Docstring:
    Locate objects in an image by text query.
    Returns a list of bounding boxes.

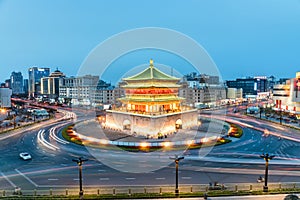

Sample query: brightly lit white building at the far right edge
[272,72,300,115]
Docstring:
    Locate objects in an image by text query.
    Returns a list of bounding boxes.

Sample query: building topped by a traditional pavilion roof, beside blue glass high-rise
[41,69,66,99]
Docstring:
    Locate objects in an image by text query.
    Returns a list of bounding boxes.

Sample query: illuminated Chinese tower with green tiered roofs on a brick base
[102,60,198,138]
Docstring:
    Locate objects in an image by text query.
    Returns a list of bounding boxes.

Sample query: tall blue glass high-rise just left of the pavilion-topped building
[28,67,50,97]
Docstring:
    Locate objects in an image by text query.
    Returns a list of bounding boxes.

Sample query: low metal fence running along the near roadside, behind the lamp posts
[0,182,300,197]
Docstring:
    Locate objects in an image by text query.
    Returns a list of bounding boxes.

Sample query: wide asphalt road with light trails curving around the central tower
[0,108,300,193]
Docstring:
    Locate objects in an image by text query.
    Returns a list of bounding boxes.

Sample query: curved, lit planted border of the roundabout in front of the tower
[62,124,231,152]
